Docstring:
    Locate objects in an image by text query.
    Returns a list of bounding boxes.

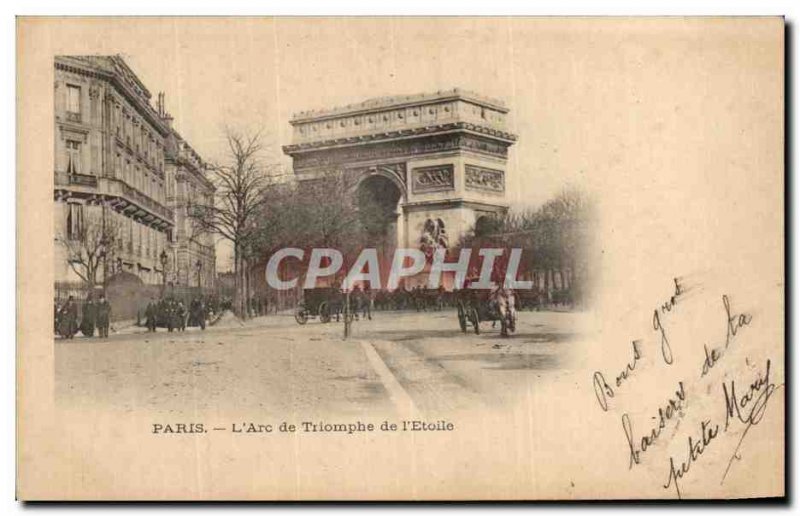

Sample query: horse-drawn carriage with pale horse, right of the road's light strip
[456,289,517,337]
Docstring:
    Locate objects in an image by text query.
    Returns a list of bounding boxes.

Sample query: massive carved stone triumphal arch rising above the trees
[283,89,516,258]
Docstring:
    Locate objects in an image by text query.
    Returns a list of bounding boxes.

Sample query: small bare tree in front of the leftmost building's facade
[56,212,120,289]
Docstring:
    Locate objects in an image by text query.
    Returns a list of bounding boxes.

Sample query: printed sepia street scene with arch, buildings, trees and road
[54,55,591,422]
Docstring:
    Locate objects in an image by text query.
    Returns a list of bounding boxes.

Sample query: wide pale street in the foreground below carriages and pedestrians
[55,310,584,418]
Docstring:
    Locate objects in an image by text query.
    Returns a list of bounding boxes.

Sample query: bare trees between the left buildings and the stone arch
[190,131,380,318]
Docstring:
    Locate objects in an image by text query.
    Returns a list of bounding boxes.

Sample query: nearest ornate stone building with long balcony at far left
[54,56,213,286]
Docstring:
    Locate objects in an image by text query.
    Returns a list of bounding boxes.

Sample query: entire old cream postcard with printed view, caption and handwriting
[17,17,787,500]
